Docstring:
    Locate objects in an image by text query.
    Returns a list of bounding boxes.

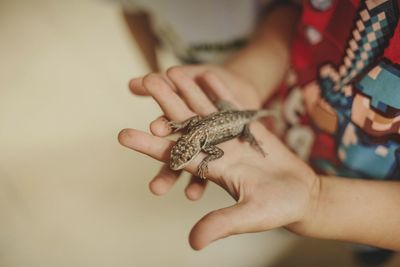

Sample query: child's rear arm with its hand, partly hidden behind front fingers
[130,2,300,108]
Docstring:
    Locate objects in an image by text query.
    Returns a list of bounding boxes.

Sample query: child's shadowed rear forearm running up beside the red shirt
[224,4,300,101]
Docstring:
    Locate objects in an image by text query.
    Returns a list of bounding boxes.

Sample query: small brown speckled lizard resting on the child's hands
[168,101,274,179]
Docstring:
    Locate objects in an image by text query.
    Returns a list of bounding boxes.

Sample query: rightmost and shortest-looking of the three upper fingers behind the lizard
[201,71,240,107]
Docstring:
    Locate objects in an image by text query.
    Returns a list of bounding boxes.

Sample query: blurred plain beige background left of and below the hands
[0,0,396,267]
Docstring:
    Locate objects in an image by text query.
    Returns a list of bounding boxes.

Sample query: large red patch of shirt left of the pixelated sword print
[291,0,359,85]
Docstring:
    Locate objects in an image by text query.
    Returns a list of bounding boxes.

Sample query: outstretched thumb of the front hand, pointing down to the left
[189,202,254,250]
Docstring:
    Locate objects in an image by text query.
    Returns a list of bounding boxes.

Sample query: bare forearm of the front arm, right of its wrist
[294,176,400,250]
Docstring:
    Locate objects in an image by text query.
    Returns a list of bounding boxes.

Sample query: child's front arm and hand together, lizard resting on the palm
[119,72,400,249]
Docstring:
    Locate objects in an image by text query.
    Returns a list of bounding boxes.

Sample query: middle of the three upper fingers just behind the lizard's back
[167,67,216,116]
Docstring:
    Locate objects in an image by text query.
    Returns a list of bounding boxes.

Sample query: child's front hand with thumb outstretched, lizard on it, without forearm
[119,70,319,249]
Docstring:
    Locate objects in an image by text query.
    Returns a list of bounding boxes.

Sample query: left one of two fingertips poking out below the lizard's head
[149,164,182,196]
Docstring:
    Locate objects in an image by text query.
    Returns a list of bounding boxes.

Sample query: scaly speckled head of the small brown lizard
[170,138,201,170]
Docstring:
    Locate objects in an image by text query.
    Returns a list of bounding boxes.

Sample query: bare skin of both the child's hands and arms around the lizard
[119,3,400,250]
